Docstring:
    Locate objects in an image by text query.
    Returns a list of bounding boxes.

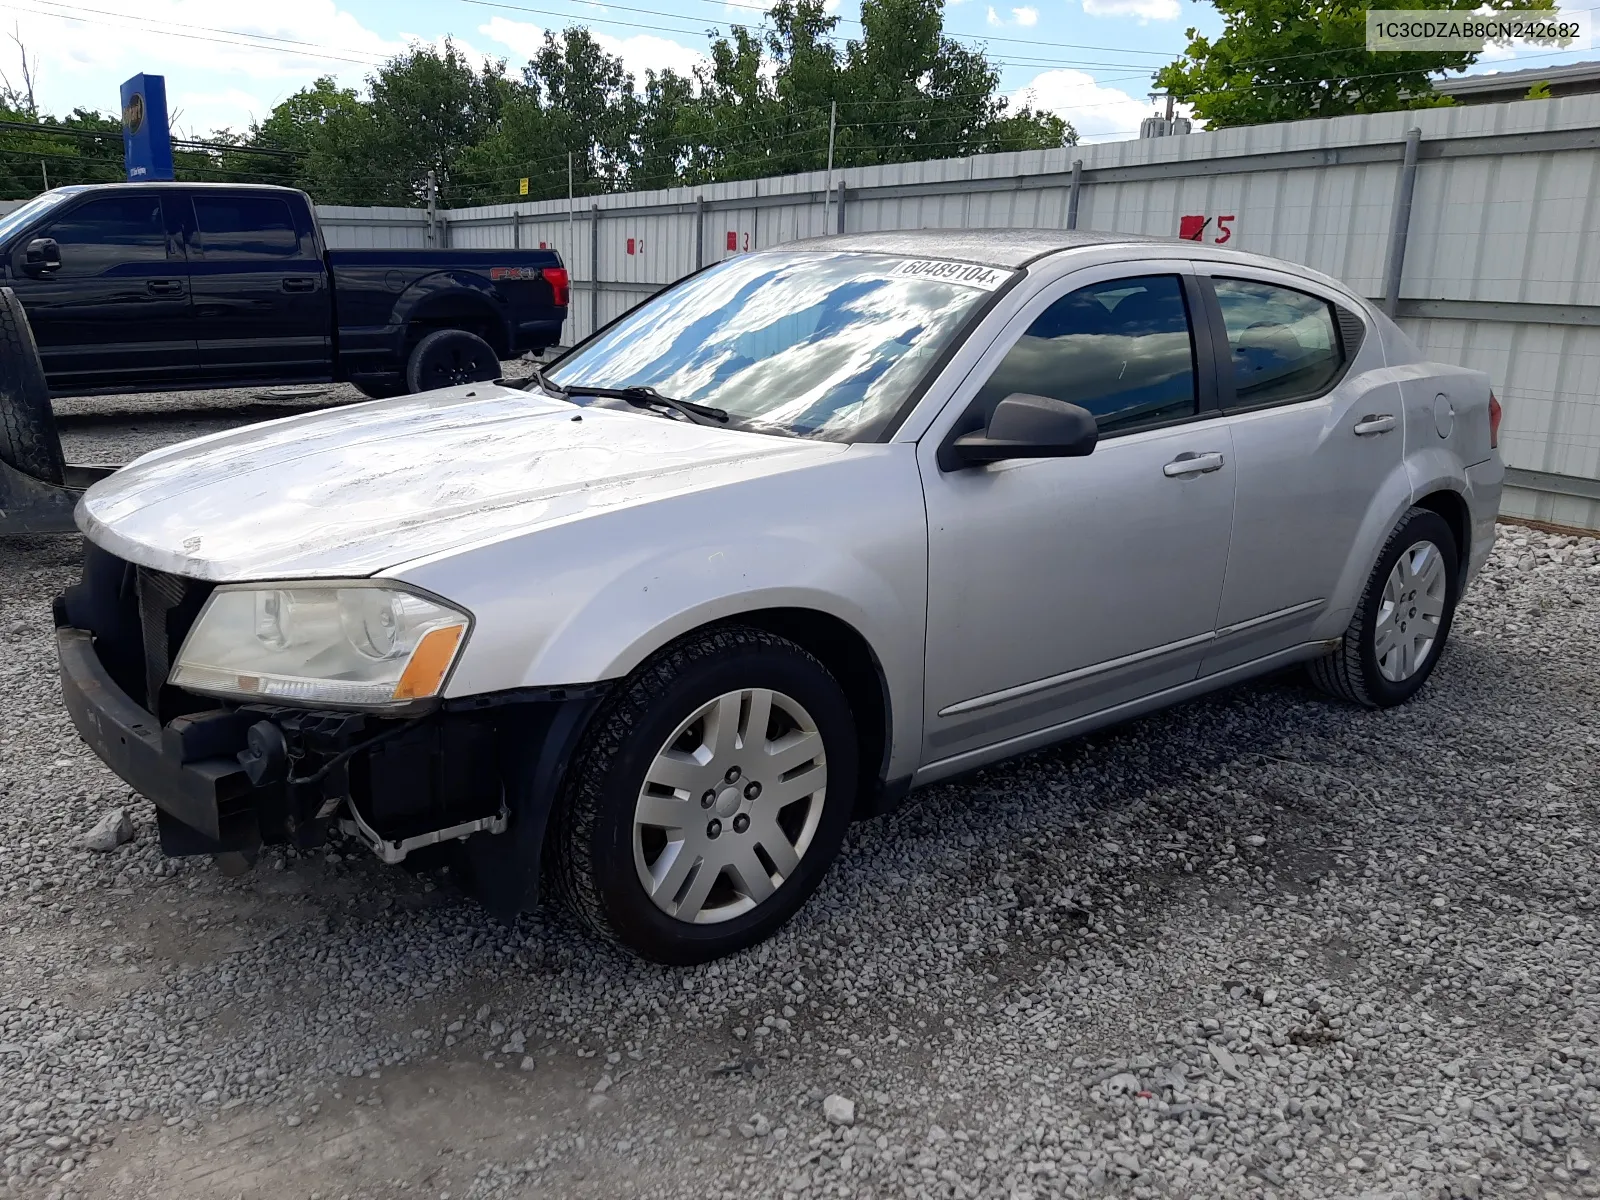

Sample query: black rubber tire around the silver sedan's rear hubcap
[1307,509,1461,709]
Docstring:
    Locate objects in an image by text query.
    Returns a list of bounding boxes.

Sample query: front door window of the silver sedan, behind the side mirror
[979,275,1198,434]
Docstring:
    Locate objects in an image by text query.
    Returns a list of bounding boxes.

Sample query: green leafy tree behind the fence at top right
[1155,0,1552,128]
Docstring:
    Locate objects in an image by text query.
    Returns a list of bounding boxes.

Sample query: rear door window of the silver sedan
[1211,278,1344,408]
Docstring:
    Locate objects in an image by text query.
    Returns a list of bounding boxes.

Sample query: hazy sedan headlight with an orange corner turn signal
[170,584,470,707]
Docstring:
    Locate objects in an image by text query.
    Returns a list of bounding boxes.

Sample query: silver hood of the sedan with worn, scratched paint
[77,384,846,582]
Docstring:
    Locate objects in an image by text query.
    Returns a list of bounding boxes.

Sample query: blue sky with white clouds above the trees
[0,0,1600,141]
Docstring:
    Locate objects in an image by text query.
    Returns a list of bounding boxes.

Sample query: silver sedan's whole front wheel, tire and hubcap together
[552,626,858,965]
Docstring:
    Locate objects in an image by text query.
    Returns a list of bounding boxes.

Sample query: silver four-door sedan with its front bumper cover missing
[58,230,1504,963]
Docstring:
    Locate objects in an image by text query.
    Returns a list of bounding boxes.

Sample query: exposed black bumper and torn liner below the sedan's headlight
[56,605,605,915]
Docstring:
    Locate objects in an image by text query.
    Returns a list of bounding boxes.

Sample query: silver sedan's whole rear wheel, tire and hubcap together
[1307,509,1459,709]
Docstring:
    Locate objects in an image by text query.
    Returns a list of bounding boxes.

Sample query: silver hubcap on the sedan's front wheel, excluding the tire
[634,688,827,925]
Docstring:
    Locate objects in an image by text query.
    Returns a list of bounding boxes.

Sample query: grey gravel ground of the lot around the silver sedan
[0,396,1600,1200]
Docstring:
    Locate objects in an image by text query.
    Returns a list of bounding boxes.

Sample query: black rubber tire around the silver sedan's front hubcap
[550,626,858,965]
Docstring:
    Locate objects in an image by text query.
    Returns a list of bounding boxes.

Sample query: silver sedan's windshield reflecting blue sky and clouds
[550,251,1010,442]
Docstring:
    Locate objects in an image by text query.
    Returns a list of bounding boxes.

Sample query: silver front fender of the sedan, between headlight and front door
[388,445,928,778]
